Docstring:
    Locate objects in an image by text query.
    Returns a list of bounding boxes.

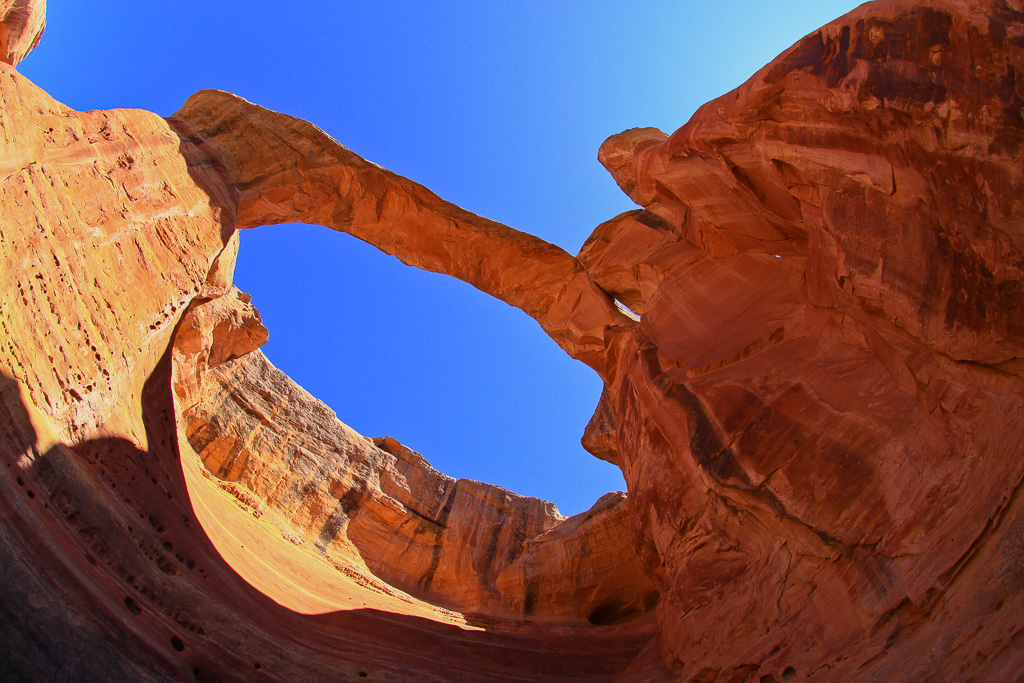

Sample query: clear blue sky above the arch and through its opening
[19,0,859,514]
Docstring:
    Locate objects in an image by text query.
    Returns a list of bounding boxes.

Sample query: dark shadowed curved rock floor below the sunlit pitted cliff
[0,350,663,681]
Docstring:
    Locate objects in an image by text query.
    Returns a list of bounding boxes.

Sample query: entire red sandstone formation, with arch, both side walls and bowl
[0,0,1024,681]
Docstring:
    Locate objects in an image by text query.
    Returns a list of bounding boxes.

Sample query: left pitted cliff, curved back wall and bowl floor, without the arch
[0,57,656,681]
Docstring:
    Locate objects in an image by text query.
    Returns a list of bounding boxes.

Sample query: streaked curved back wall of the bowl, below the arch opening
[173,290,657,630]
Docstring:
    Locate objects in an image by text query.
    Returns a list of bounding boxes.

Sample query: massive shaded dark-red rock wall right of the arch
[593,2,1024,680]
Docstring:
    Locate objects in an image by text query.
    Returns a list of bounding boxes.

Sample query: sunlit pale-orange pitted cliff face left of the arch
[0,58,231,447]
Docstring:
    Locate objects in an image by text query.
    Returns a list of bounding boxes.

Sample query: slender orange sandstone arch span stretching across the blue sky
[170,90,629,373]
